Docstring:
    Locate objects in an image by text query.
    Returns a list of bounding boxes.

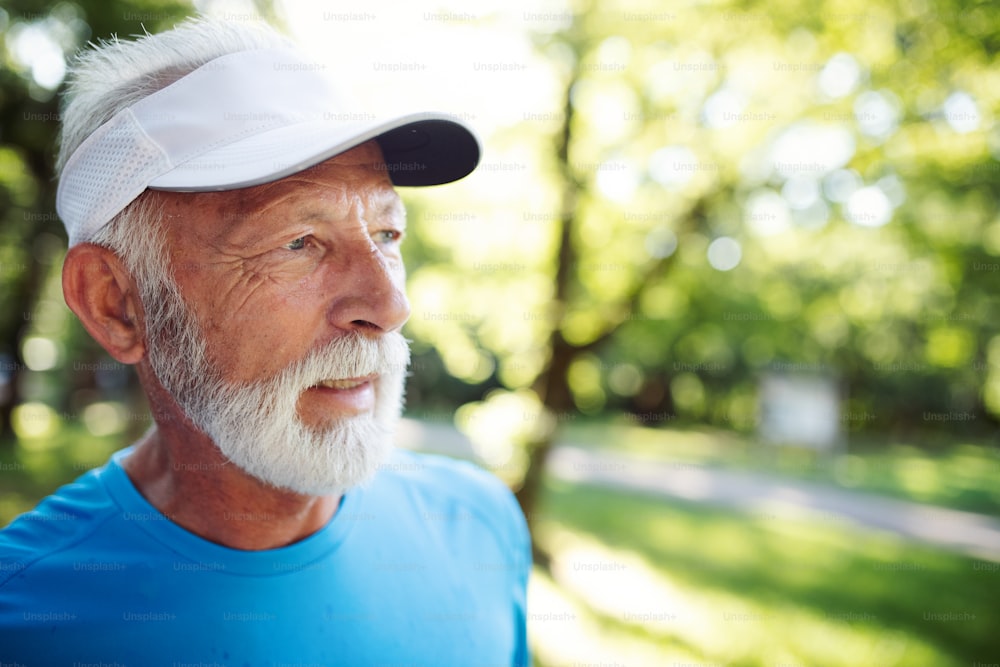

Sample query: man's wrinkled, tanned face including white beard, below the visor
[140,142,409,495]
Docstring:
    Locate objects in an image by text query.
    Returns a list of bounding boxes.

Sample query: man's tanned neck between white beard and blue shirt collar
[123,418,340,551]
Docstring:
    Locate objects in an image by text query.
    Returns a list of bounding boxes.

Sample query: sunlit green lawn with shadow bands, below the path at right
[530,480,1000,667]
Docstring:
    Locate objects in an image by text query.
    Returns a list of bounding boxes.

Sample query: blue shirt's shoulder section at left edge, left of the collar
[0,468,114,588]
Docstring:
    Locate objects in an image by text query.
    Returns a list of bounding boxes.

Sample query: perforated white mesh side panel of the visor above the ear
[56,109,170,245]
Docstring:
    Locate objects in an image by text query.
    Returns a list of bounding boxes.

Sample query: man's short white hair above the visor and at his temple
[56,18,289,294]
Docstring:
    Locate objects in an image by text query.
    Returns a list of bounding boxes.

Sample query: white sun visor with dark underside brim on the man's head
[56,49,481,246]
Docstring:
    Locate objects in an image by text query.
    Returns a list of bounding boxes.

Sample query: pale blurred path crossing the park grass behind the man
[399,419,1000,562]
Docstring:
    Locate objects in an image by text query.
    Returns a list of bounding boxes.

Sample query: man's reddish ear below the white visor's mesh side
[63,243,146,364]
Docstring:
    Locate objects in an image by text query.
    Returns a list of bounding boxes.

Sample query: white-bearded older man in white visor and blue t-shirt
[0,15,530,667]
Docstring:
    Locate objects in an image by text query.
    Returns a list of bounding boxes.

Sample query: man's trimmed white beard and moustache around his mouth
[147,278,410,496]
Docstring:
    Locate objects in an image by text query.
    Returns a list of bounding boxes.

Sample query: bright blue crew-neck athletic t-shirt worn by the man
[0,450,531,667]
